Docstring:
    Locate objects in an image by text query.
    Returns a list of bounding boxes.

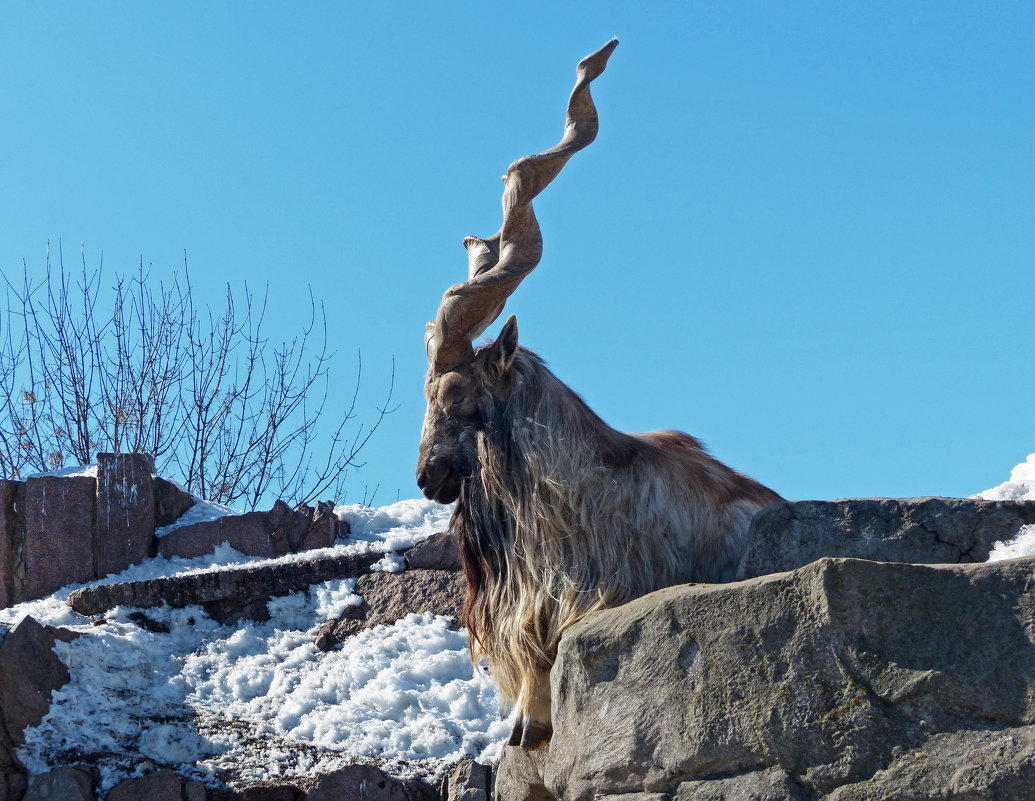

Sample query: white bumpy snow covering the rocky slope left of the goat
[0,500,509,792]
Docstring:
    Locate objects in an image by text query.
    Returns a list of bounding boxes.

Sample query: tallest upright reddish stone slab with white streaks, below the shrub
[93,453,155,577]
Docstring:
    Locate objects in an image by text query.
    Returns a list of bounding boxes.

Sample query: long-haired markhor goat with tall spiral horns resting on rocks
[417,41,779,748]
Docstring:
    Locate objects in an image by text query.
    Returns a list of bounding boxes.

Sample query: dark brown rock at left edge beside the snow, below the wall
[0,617,76,746]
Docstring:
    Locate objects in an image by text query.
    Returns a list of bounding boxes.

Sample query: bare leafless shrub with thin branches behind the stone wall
[0,248,394,509]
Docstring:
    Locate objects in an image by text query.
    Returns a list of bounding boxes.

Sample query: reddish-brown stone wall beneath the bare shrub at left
[0,453,348,607]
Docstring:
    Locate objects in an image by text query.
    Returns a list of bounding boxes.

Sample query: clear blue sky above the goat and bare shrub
[0,6,1035,502]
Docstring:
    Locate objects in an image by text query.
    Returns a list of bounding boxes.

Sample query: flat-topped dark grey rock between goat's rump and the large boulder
[739,498,1035,579]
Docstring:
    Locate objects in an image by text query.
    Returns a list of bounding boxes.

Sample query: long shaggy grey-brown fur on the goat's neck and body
[452,348,779,728]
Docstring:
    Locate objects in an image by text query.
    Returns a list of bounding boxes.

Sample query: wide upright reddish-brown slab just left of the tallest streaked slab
[16,475,97,600]
